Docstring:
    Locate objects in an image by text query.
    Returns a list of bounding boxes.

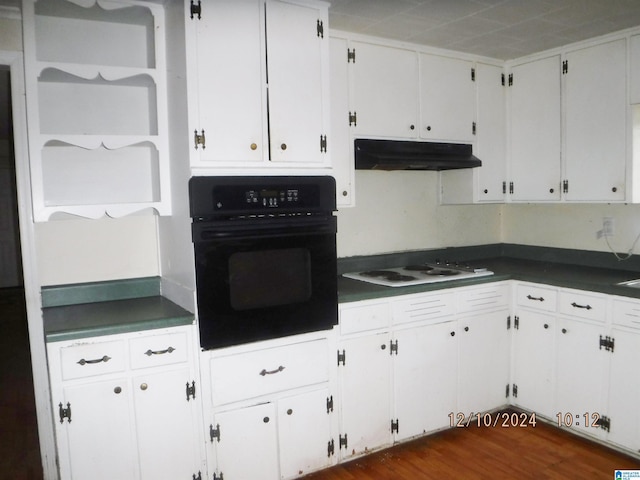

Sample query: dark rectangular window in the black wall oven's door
[229,248,311,311]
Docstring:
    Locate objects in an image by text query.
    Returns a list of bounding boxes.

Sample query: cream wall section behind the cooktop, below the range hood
[337,170,503,257]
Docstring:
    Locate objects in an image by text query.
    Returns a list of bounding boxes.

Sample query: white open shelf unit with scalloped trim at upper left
[22,0,171,221]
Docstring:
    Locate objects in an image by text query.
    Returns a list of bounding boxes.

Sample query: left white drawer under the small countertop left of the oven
[60,340,127,380]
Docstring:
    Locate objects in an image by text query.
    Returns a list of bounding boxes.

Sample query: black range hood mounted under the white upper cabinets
[355,138,482,170]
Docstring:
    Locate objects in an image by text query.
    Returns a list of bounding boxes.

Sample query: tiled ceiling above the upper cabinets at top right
[329,0,640,60]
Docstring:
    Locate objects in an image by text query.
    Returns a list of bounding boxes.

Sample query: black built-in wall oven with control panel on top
[189,176,338,349]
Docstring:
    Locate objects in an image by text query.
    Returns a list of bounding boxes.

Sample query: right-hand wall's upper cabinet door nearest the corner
[507,55,561,201]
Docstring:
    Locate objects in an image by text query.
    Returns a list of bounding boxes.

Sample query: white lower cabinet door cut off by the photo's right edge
[606,327,640,452]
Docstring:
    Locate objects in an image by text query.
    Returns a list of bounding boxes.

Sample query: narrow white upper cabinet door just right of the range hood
[473,63,507,202]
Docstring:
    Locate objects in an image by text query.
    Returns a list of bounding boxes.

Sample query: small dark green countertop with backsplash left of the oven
[42,277,194,342]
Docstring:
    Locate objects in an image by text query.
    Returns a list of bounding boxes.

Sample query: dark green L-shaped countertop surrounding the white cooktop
[338,249,640,303]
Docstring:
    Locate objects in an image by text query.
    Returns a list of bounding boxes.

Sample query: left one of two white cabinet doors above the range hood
[350,42,418,138]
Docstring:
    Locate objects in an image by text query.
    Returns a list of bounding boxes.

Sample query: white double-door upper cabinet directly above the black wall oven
[186,0,330,168]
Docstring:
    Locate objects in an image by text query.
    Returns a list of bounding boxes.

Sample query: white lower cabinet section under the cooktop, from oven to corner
[338,282,510,459]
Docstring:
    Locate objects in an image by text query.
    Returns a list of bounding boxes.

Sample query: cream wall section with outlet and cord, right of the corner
[502,204,640,253]
